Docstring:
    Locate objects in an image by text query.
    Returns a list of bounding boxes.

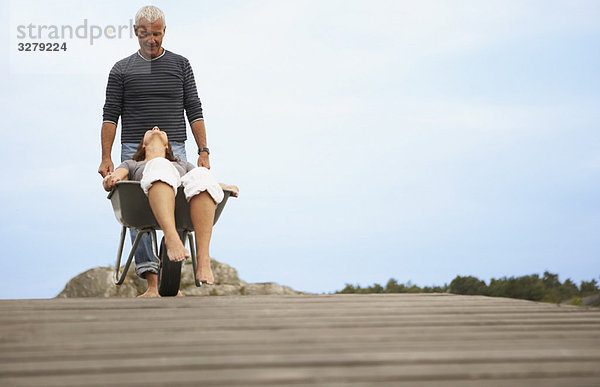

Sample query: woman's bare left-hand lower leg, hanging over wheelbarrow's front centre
[148,181,190,262]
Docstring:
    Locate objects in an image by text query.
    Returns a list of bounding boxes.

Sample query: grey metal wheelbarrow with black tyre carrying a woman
[108,181,233,296]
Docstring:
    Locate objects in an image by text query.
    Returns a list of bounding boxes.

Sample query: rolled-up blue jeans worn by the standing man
[121,141,187,278]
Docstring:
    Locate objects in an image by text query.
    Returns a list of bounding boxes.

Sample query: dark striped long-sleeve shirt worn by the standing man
[103,50,203,143]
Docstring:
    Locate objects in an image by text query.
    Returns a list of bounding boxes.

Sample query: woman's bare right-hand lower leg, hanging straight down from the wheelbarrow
[190,191,216,285]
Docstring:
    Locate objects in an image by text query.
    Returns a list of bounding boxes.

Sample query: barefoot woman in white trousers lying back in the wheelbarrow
[103,126,238,297]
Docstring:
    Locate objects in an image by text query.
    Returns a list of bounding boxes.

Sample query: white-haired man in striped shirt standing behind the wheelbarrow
[98,6,213,297]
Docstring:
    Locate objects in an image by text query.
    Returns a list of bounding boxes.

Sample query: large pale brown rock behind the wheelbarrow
[56,259,300,298]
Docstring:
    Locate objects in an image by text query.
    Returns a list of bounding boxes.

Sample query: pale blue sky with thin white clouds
[0,0,600,298]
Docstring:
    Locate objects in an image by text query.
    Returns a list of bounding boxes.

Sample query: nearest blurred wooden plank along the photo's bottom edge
[2,362,600,386]
